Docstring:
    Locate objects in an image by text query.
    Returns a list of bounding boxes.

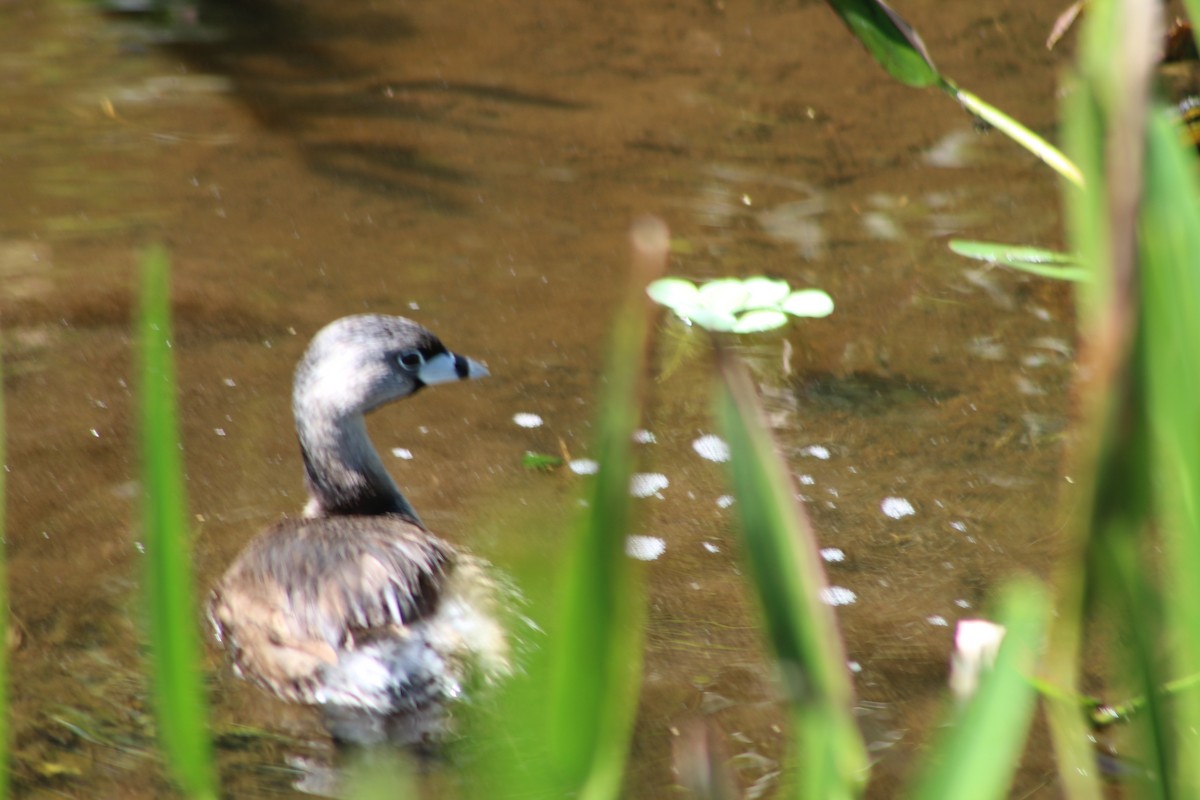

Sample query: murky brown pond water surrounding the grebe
[0,0,1073,798]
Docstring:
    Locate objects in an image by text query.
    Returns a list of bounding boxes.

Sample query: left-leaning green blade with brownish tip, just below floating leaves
[716,349,866,800]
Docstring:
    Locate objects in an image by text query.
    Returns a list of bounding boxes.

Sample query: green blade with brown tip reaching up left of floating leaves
[546,219,670,800]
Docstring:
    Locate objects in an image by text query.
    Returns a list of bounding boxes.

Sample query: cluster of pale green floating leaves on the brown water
[646,277,833,333]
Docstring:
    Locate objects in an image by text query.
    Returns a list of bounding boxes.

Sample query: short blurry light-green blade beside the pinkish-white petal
[911,581,1049,800]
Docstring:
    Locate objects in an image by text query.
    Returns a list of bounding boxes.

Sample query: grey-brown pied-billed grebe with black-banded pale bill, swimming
[209,314,509,742]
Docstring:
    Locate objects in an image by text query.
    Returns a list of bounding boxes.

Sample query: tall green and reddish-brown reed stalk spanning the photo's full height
[1046,0,1162,800]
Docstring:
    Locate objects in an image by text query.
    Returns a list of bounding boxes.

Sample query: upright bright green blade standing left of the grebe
[139,247,217,799]
